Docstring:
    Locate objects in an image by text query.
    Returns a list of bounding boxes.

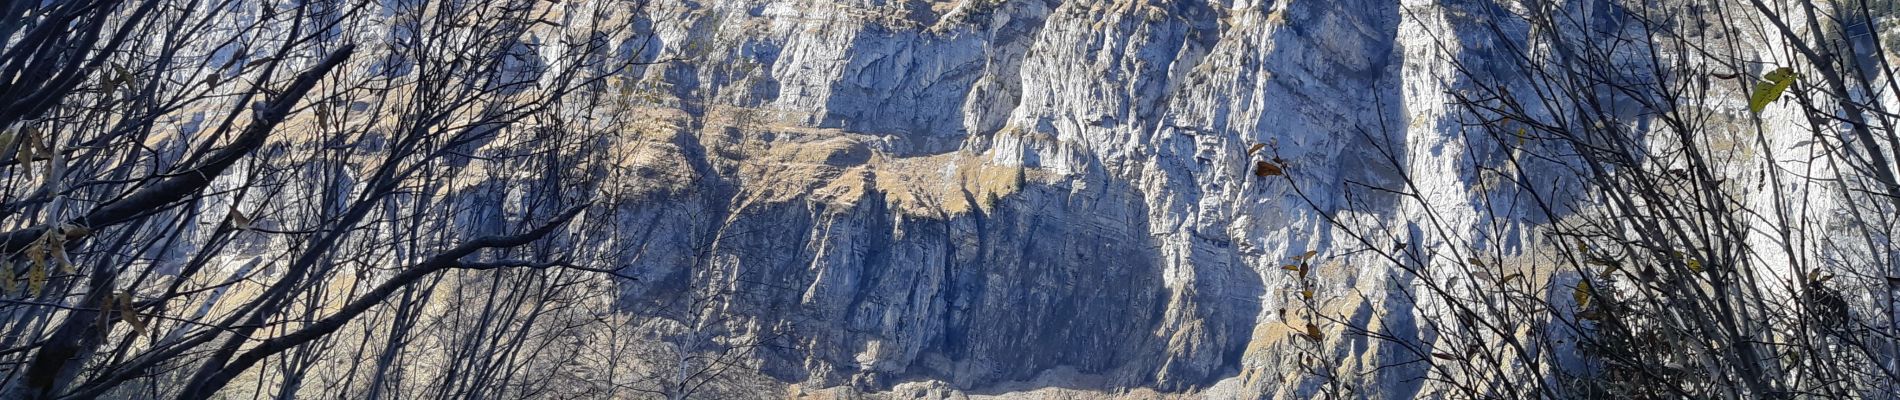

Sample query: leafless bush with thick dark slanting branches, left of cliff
[0,0,661,398]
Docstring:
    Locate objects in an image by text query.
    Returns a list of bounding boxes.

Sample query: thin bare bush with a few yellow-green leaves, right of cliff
[1286,0,1900,398]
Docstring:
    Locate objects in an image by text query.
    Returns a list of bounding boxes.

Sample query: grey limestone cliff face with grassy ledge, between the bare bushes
[600,0,1484,398]
